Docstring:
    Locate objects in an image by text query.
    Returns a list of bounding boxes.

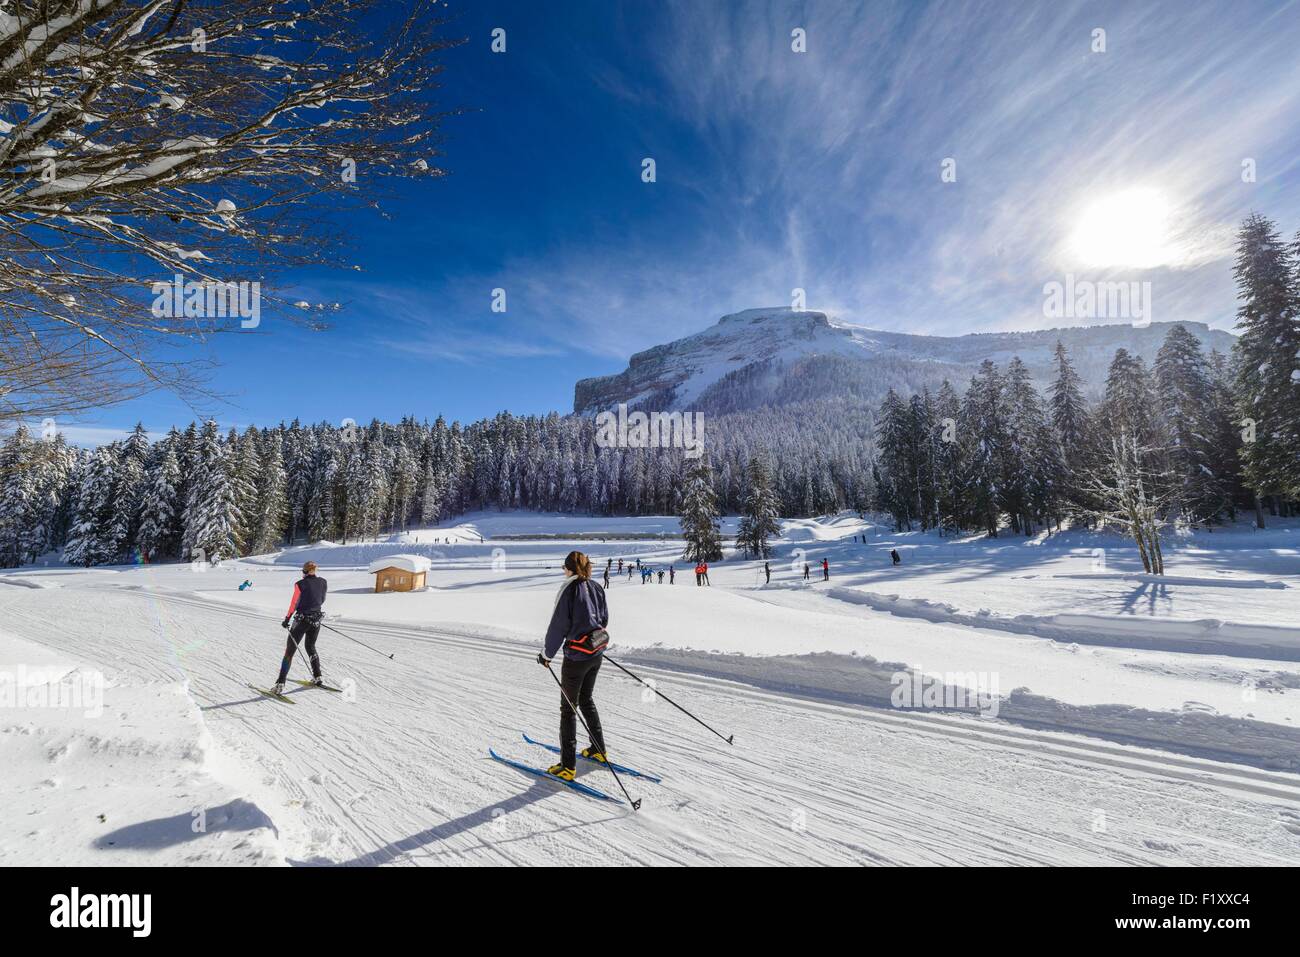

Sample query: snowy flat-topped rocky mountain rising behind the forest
[573,307,1236,415]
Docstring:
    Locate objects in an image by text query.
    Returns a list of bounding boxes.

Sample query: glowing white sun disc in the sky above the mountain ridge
[1069,187,1178,269]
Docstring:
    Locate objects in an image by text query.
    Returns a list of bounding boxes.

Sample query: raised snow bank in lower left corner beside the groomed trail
[0,635,283,866]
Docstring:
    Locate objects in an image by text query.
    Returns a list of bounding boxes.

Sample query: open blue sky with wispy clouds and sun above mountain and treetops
[68,0,1300,439]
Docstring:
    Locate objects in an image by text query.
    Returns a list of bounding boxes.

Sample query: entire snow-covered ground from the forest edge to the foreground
[0,512,1300,865]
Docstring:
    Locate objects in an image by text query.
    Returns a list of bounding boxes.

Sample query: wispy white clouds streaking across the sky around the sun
[508,0,1300,352]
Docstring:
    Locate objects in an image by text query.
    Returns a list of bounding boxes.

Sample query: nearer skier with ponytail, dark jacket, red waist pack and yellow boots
[537,551,610,781]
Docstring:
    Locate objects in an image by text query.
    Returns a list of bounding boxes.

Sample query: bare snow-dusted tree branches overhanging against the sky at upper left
[0,0,455,420]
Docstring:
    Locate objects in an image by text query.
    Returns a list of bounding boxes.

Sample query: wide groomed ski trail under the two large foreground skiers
[0,584,1300,866]
